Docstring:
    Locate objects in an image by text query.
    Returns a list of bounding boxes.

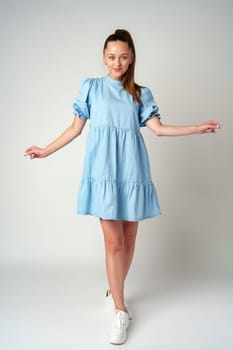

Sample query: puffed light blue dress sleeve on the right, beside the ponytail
[139,88,160,126]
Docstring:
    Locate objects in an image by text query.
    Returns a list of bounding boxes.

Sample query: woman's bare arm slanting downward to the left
[24,116,86,159]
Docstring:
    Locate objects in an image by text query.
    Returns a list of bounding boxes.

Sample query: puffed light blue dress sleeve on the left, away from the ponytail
[72,78,93,119]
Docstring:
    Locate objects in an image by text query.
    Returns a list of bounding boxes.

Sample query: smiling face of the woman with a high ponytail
[103,40,133,80]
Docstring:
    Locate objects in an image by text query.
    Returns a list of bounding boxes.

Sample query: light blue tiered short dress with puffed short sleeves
[73,76,160,221]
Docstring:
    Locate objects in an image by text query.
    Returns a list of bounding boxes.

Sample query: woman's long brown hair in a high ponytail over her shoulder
[103,29,141,104]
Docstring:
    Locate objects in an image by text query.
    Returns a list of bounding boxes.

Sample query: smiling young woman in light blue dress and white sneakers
[25,29,220,344]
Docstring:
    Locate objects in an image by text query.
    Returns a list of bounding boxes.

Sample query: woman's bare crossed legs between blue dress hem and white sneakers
[100,219,138,311]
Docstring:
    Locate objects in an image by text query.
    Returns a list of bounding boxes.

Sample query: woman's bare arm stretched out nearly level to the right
[146,116,220,136]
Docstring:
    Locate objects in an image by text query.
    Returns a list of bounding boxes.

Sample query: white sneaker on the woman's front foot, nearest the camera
[109,310,129,345]
